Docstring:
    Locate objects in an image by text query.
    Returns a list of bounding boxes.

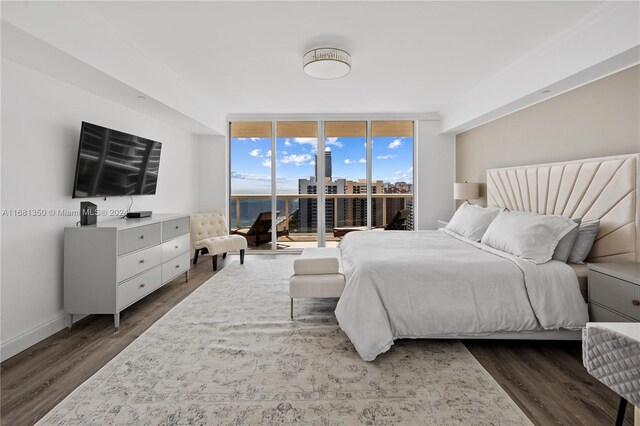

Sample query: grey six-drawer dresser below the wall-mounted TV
[64,214,191,329]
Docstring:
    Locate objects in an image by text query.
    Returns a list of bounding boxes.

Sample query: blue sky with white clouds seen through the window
[231,137,413,194]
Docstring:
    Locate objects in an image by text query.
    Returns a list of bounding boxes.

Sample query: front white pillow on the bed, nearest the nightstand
[482,211,578,264]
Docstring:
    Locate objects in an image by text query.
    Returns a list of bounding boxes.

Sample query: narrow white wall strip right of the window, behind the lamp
[417,121,455,229]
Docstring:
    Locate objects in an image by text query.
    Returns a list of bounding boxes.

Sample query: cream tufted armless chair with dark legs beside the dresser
[191,212,247,271]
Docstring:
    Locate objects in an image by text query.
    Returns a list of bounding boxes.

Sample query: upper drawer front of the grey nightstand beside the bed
[589,271,640,321]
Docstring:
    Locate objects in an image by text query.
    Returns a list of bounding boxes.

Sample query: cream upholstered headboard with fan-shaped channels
[487,154,640,262]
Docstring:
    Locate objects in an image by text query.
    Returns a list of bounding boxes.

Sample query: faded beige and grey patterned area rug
[40,256,530,425]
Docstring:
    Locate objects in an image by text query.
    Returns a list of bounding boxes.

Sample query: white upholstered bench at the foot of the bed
[289,247,345,318]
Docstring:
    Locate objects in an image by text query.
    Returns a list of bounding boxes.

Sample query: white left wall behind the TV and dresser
[0,58,199,360]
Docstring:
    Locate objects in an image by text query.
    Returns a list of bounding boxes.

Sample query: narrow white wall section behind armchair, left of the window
[198,135,229,216]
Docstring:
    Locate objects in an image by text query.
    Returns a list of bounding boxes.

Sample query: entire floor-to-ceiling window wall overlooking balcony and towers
[229,120,414,250]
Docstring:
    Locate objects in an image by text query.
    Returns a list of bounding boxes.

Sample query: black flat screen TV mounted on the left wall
[73,121,162,198]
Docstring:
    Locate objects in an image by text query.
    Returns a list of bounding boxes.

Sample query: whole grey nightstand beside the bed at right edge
[588,263,640,322]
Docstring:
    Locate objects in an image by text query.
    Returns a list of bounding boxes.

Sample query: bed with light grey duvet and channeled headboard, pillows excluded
[336,154,640,361]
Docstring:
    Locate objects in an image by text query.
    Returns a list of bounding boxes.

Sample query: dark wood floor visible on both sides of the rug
[0,256,633,426]
